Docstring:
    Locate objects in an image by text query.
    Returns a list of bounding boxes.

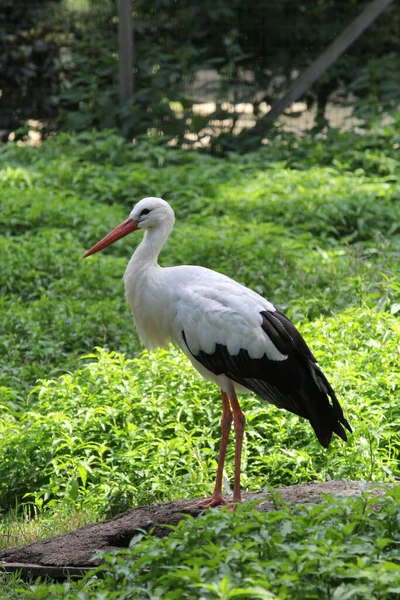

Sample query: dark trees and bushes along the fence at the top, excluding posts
[0,0,400,145]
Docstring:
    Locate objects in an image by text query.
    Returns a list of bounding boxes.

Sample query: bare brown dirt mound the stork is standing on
[0,480,385,579]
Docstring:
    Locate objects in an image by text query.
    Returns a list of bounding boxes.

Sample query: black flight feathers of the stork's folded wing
[182,310,351,447]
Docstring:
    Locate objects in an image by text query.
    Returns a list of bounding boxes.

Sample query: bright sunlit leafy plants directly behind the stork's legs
[0,308,400,513]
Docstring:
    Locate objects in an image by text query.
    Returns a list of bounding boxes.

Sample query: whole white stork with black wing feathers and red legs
[84,198,351,508]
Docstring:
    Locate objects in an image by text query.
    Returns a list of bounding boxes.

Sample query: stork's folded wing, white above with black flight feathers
[177,286,351,446]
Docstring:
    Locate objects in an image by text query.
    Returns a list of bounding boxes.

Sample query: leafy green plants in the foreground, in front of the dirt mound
[30,490,400,600]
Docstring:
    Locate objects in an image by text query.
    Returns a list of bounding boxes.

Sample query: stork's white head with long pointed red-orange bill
[83,197,175,258]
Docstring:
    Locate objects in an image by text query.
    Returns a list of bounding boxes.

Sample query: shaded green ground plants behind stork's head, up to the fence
[0,132,400,401]
